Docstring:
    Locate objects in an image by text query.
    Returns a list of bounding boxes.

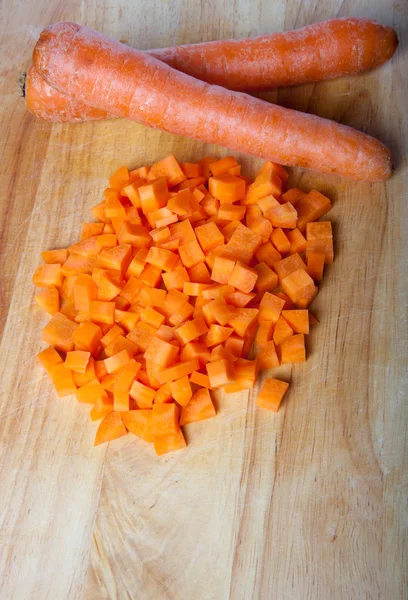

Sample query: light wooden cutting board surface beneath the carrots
[0,0,408,600]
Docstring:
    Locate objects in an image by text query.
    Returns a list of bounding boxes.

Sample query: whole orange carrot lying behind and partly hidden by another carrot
[25,19,398,122]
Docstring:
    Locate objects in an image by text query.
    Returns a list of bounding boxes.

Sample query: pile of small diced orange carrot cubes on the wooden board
[33,155,333,455]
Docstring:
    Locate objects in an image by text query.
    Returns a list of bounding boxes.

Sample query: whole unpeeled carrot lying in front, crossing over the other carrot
[33,23,392,181]
